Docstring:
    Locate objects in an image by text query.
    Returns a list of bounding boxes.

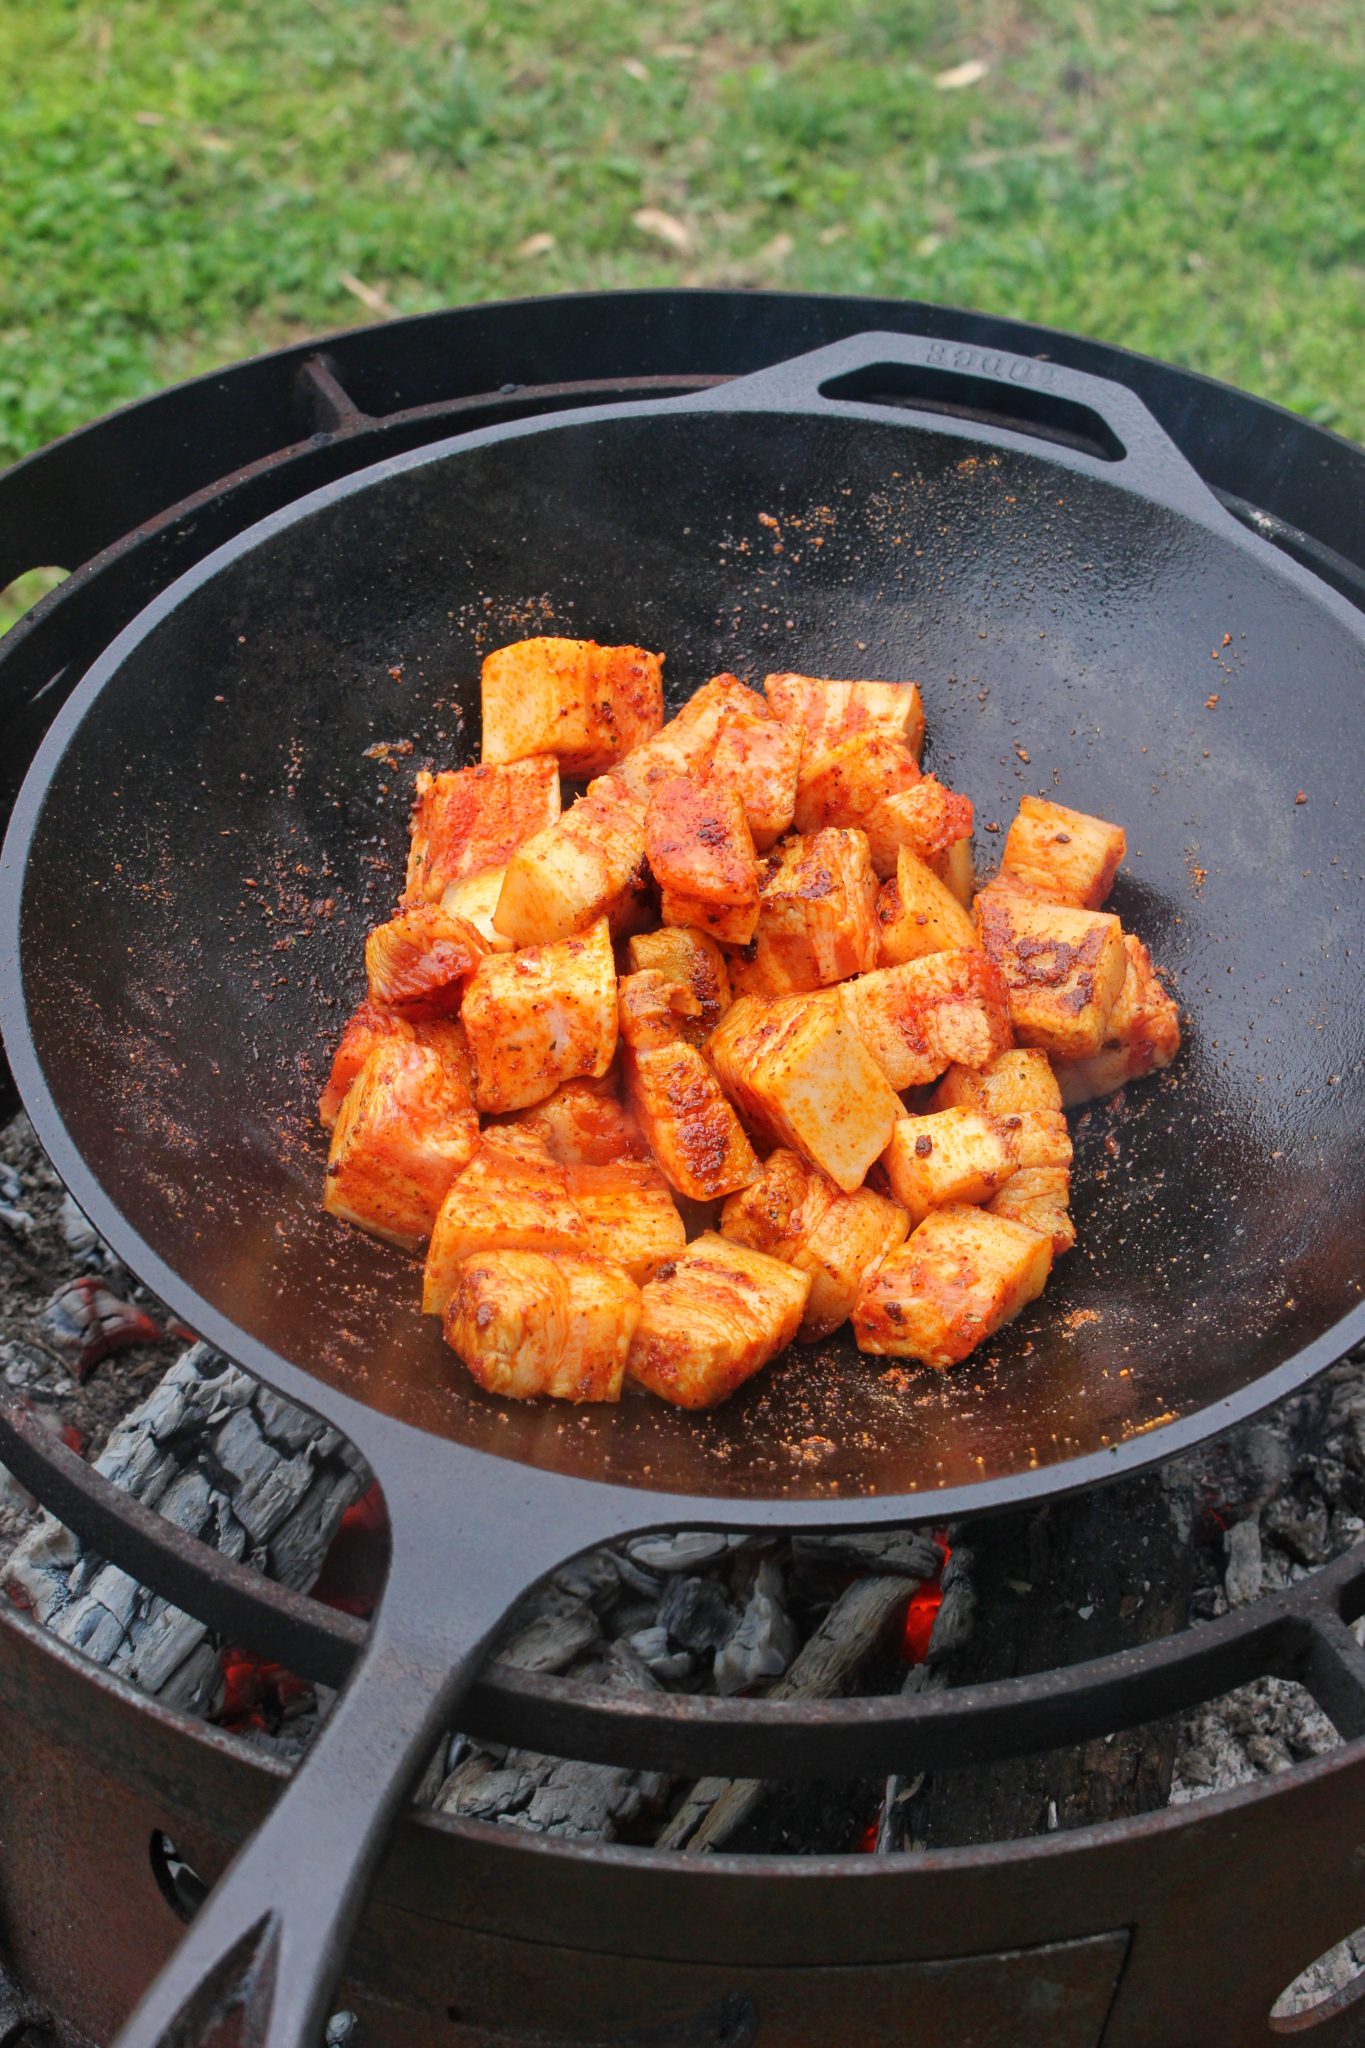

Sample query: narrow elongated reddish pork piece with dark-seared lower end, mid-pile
[618,969,759,1202]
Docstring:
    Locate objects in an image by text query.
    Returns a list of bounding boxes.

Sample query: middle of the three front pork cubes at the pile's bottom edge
[626,1231,810,1409]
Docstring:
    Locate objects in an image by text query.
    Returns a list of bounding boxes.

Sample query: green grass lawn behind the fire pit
[0,0,1365,622]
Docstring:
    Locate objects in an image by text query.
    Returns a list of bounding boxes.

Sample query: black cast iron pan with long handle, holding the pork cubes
[2,334,1365,2048]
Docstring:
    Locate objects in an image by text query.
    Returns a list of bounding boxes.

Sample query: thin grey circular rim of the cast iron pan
[0,397,1365,1528]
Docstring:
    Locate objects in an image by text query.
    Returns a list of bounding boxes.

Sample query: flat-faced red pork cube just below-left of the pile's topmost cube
[403,754,559,909]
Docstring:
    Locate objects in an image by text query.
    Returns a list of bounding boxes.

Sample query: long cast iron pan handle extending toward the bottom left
[115,1497,606,2048]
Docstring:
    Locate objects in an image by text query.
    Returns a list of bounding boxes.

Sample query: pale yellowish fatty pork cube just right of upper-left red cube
[493,776,649,946]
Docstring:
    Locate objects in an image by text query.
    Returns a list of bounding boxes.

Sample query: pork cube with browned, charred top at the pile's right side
[976,883,1128,1059]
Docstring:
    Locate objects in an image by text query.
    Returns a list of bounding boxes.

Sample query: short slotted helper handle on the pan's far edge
[687,330,1242,520]
